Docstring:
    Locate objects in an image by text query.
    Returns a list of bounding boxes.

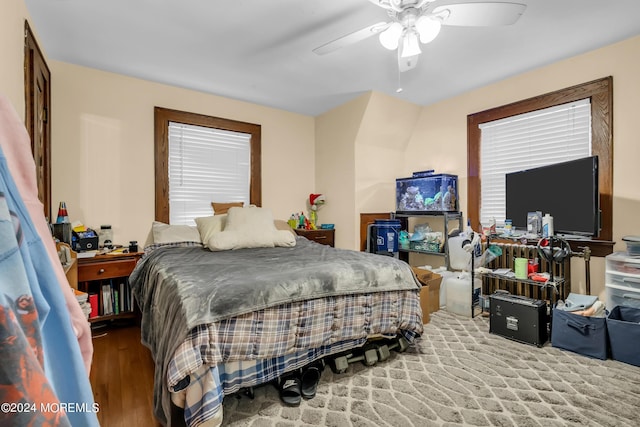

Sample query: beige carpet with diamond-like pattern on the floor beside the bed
[224,310,640,427]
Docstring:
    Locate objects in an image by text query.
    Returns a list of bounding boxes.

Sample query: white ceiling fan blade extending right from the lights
[431,2,527,27]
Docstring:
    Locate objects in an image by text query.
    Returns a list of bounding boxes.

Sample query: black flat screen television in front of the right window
[505,156,600,237]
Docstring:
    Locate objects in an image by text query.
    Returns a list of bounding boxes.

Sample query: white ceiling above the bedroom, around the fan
[25,0,640,116]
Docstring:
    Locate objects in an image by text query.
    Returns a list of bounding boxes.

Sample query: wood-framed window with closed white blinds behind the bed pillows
[155,107,261,224]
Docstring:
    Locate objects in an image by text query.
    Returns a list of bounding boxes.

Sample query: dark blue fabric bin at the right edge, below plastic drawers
[607,305,640,366]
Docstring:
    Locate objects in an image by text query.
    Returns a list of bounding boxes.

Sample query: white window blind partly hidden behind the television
[479,98,591,224]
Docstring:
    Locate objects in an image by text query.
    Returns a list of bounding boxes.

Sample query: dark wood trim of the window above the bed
[154,107,262,223]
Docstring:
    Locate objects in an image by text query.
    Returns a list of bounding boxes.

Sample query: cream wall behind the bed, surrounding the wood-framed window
[49,61,315,247]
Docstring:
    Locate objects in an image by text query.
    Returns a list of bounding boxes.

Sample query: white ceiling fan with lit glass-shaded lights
[313,0,527,72]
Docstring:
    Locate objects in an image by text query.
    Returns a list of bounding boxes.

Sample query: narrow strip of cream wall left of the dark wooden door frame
[0,0,37,120]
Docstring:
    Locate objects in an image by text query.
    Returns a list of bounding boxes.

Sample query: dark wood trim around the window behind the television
[467,76,613,256]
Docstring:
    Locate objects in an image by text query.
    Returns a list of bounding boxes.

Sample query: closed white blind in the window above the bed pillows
[169,122,251,225]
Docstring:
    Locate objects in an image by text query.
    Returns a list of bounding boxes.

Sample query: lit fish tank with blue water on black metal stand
[396,172,458,214]
